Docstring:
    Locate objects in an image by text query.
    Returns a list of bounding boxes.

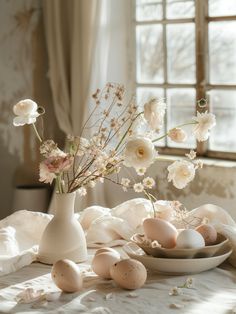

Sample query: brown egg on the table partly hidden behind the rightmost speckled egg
[91,252,120,279]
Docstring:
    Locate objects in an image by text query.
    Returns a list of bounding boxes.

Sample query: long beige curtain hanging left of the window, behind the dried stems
[43,0,131,211]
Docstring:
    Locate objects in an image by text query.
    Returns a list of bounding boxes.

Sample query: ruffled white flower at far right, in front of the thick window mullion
[193,111,216,142]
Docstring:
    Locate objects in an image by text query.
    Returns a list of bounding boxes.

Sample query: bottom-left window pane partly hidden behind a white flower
[137,87,165,147]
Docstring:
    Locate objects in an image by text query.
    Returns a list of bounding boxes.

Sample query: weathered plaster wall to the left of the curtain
[0,0,61,218]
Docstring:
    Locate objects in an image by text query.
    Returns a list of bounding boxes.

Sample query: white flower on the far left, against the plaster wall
[13,99,40,126]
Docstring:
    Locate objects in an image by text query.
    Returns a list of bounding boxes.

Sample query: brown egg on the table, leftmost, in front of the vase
[51,259,83,292]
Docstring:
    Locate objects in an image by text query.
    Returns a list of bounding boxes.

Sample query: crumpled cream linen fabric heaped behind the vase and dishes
[0,198,236,276]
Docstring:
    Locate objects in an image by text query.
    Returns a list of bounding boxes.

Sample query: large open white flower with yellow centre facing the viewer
[123,136,157,169]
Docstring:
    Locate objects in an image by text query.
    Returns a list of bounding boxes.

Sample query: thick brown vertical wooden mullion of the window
[195,0,209,155]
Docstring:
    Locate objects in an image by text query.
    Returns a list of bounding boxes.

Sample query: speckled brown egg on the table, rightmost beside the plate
[110,259,147,290]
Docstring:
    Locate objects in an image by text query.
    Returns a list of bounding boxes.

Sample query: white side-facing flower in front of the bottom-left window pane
[144,99,166,131]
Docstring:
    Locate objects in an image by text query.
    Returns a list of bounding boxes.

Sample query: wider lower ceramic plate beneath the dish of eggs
[123,242,232,275]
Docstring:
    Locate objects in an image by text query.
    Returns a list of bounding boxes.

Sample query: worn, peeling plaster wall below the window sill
[103,156,236,220]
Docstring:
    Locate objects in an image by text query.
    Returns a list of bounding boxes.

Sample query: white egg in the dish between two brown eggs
[176,229,205,249]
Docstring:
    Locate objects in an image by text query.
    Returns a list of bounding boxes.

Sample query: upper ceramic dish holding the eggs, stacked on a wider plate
[131,233,229,258]
